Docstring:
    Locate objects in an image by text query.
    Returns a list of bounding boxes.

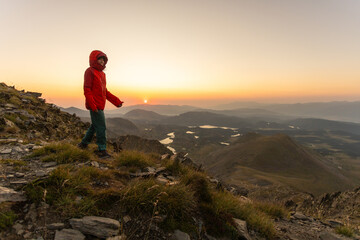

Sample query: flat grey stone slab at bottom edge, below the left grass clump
[70,216,120,239]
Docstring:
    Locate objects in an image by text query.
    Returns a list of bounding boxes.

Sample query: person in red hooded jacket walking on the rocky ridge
[78,50,123,158]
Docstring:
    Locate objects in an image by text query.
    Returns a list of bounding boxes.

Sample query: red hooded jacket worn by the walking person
[84,50,122,111]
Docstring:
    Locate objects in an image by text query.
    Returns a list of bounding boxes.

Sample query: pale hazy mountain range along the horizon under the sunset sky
[62,101,360,123]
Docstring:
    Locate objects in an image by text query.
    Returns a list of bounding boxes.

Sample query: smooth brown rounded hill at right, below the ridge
[200,134,353,195]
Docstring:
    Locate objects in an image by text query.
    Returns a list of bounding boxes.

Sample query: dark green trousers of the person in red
[81,110,106,151]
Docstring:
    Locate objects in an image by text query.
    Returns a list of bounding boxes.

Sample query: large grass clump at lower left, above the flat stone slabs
[24,165,100,217]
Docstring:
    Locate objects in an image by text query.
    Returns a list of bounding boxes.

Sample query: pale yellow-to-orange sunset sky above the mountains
[0,0,360,108]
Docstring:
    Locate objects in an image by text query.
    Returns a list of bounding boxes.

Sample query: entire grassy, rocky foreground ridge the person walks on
[0,83,359,240]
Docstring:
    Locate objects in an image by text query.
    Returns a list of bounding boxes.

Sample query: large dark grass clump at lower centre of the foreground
[119,179,196,232]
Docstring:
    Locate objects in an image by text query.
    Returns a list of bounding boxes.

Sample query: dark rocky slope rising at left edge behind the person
[0,83,87,141]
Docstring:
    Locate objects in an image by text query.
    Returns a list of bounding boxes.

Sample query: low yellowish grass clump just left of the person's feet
[28,143,90,164]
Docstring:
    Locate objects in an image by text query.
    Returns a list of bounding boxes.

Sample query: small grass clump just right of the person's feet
[114,150,158,169]
